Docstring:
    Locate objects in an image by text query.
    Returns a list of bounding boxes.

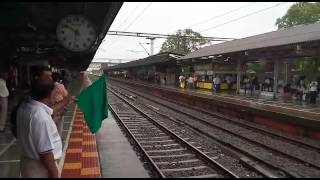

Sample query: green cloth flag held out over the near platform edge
[77,75,108,133]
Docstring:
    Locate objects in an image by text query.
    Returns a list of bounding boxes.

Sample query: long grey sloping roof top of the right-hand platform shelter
[178,23,320,60]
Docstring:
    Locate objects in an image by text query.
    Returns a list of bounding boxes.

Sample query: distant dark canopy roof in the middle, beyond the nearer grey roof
[106,52,182,71]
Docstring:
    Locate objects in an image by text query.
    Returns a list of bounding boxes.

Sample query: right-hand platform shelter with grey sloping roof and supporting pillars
[177,23,320,98]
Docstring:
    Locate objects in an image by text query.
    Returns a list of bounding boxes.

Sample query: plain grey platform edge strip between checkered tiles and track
[96,111,149,178]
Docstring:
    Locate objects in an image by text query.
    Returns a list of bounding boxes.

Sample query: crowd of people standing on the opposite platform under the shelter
[179,75,320,104]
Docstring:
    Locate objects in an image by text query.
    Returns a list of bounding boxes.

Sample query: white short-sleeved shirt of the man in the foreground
[17,100,62,160]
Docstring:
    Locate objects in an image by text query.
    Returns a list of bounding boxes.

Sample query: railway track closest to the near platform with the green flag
[109,91,238,178]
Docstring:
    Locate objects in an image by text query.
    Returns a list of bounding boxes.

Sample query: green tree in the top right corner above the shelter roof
[276,2,320,29]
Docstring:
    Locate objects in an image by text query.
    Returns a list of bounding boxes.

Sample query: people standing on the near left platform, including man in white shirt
[0,66,75,178]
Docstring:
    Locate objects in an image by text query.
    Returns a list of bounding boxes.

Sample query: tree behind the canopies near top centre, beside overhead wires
[160,29,209,55]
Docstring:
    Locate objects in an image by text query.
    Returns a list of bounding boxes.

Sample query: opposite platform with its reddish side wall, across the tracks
[109,78,320,139]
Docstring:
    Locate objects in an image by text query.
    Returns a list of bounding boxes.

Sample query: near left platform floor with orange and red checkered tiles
[0,72,150,178]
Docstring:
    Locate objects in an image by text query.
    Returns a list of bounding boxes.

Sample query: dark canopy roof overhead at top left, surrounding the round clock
[0,2,123,70]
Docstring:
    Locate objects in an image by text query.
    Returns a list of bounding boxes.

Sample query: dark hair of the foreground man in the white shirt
[31,81,54,101]
